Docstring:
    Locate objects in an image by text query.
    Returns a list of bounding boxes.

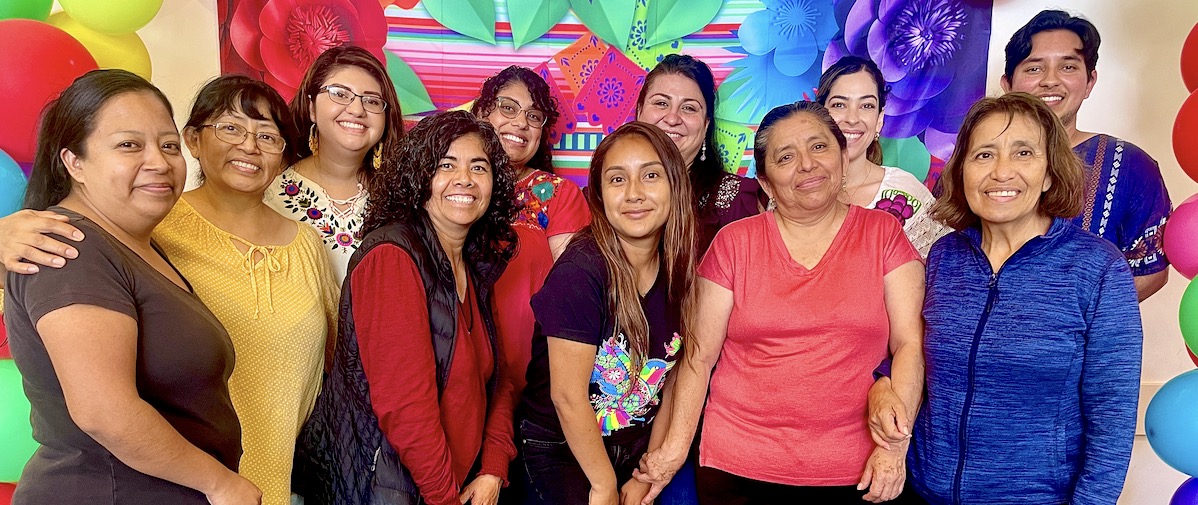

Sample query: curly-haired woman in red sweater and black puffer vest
[296,111,515,505]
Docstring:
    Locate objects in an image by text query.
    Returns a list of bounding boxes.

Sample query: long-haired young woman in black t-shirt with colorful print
[520,122,695,505]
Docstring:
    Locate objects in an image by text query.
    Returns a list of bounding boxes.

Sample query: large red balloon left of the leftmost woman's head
[0,19,96,163]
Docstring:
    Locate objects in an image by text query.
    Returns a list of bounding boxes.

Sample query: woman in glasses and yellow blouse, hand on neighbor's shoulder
[0,75,338,505]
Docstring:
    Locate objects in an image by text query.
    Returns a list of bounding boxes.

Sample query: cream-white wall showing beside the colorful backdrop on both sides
[126,0,1198,505]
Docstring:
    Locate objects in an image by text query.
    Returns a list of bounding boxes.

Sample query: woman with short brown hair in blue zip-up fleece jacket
[908,93,1143,505]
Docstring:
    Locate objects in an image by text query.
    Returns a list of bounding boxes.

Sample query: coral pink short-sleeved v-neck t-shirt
[698,206,920,486]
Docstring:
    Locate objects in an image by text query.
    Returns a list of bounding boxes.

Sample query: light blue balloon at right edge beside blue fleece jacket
[1144,370,1198,476]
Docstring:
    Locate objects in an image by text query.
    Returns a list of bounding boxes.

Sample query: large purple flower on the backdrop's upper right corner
[823,0,992,159]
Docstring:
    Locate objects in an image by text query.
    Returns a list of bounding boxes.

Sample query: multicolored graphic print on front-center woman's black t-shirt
[591,333,682,437]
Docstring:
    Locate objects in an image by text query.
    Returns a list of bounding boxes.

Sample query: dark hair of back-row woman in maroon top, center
[636,54,725,205]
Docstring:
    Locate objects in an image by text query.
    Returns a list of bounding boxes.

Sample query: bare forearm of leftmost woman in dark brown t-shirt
[72,398,240,494]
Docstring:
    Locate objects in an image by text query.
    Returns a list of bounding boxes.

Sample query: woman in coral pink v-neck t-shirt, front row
[641,102,924,504]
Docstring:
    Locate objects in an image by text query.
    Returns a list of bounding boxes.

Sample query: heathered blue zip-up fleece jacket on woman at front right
[908,219,1144,505]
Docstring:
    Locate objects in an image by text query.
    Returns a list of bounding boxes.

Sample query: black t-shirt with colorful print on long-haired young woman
[521,237,682,439]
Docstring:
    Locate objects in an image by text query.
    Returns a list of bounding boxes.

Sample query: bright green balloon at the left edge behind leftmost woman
[0,359,37,482]
